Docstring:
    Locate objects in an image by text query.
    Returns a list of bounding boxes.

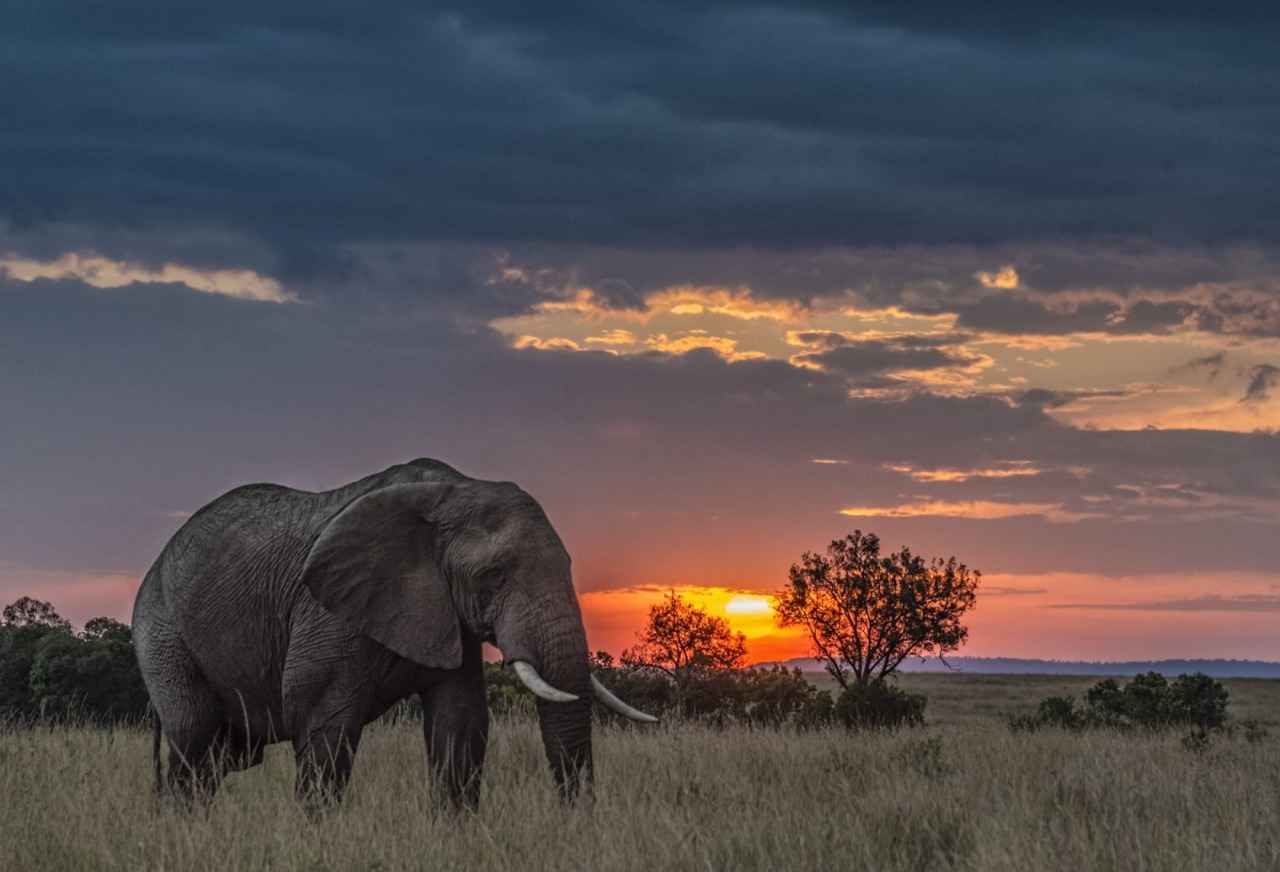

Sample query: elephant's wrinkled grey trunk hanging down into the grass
[494,585,591,800]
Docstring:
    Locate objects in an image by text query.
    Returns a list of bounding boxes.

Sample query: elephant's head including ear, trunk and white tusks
[293,465,653,796]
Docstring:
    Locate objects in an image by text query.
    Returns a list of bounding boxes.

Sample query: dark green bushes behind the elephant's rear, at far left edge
[0,597,147,723]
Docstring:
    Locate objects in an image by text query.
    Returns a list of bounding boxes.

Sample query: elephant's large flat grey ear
[302,483,462,668]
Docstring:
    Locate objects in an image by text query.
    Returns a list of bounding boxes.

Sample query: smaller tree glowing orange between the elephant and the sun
[622,590,746,695]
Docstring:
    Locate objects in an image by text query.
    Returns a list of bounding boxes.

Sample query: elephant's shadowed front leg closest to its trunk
[422,670,489,811]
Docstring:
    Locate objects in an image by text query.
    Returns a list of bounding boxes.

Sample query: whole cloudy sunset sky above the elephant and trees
[0,0,1280,659]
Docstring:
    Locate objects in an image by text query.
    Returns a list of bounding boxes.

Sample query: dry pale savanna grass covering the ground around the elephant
[0,675,1280,871]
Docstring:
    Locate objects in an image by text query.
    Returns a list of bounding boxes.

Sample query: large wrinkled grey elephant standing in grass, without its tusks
[133,460,591,808]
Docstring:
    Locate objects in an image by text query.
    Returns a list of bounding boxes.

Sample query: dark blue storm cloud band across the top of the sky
[0,3,1280,267]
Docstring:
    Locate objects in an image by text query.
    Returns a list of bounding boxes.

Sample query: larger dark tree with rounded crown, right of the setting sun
[773,530,982,690]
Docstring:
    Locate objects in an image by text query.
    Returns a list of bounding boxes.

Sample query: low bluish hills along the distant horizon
[757,657,1280,679]
